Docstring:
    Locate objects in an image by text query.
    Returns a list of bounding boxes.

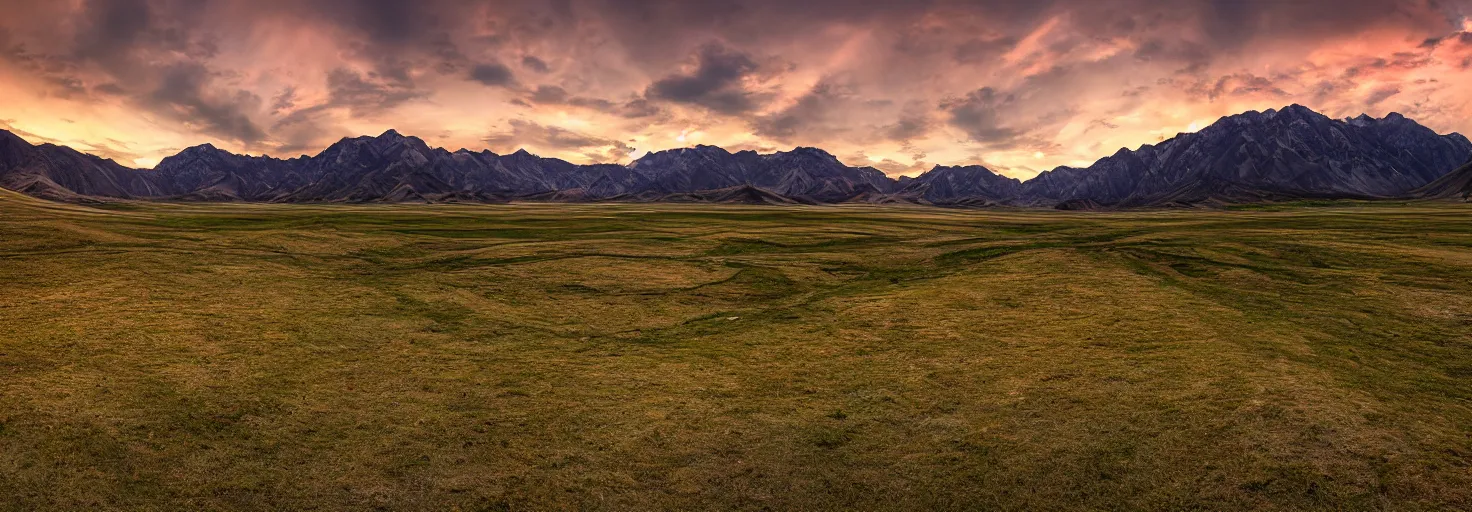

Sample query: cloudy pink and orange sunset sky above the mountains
[0,0,1472,179]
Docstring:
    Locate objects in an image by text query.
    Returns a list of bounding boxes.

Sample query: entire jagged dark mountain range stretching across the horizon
[0,104,1472,209]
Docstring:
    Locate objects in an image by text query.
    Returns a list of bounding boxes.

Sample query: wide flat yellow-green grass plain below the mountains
[0,193,1472,511]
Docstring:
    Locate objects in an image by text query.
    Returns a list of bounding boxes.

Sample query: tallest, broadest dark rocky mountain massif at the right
[1019,104,1472,206]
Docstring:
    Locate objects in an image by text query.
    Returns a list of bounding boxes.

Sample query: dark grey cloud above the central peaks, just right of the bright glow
[645,43,760,115]
